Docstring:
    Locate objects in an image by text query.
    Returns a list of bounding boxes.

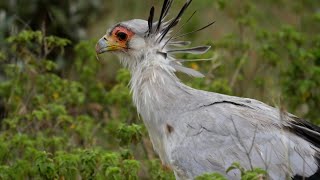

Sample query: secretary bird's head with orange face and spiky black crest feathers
[96,0,214,76]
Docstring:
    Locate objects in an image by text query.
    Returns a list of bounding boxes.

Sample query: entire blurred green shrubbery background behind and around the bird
[0,0,320,179]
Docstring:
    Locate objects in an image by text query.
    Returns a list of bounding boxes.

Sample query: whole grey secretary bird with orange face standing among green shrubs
[96,0,320,180]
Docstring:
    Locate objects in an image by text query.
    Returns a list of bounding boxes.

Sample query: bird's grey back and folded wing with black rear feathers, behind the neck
[165,88,320,179]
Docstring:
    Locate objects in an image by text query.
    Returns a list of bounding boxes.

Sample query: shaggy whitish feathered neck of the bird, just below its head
[128,54,184,118]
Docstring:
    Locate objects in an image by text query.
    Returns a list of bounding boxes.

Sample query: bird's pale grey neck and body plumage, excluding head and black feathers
[131,58,319,179]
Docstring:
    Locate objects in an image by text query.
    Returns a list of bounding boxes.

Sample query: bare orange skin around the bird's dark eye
[107,26,134,50]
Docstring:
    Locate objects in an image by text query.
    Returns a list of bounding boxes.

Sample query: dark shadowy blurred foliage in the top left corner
[0,0,103,43]
